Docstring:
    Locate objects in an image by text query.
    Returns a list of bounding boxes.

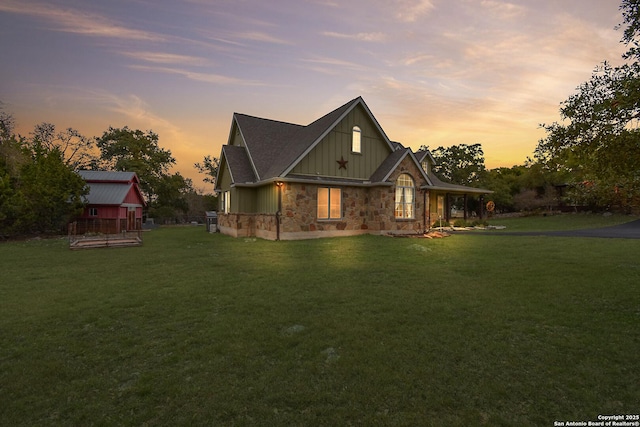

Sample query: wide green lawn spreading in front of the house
[0,218,640,426]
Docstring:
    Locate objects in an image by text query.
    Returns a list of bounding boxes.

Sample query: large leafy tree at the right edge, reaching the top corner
[535,0,640,210]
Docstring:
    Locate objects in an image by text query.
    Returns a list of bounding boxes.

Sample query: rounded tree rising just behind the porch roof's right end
[431,144,485,185]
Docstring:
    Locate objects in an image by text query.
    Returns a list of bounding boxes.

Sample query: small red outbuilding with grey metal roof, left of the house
[77,170,146,234]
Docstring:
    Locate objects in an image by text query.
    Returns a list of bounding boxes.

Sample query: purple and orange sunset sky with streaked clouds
[0,0,626,192]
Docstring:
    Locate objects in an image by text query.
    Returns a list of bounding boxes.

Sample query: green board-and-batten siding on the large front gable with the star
[291,107,391,179]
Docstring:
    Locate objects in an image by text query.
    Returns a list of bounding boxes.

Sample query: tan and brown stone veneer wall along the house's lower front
[218,158,428,240]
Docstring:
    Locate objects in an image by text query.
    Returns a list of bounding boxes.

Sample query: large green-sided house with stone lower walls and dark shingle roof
[215,97,490,240]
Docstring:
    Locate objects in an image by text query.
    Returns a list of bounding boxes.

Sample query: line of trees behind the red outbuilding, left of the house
[0,110,215,236]
